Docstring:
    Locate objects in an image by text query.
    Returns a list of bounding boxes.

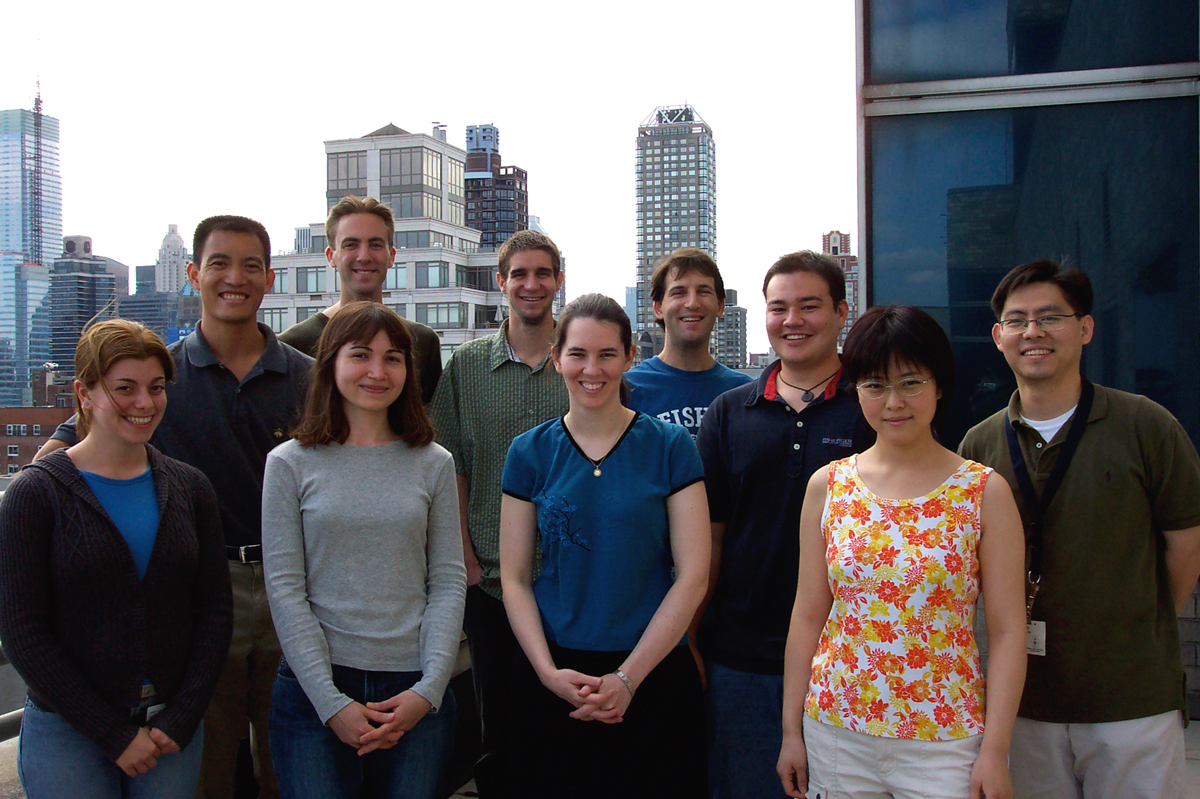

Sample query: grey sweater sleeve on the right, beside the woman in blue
[413,458,467,708]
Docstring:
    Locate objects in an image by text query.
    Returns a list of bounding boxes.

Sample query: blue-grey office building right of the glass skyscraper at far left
[48,236,118,374]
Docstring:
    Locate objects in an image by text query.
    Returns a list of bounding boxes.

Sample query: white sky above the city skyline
[0,0,858,352]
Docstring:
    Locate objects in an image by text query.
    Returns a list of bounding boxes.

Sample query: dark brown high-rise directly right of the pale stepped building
[466,125,529,250]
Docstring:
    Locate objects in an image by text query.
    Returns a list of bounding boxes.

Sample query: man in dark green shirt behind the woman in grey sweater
[280,197,442,404]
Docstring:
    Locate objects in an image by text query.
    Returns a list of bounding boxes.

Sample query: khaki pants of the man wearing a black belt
[196,560,281,799]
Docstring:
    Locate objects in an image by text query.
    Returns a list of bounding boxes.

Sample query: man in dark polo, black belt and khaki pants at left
[38,216,312,799]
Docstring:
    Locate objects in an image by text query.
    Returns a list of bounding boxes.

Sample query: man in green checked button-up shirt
[430,230,566,799]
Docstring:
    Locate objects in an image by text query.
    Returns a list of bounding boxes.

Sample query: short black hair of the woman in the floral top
[841,305,954,427]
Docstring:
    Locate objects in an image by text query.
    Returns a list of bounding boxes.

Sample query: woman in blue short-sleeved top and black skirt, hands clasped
[500,294,709,798]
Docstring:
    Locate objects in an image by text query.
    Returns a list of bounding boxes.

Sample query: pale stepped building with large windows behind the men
[262,125,560,356]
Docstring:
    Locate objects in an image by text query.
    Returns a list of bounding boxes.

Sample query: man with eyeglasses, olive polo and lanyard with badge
[959,260,1200,799]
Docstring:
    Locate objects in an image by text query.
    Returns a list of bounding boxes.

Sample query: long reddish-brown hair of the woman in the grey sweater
[293,300,433,446]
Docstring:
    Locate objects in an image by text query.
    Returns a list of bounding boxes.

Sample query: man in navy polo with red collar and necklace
[694,251,875,799]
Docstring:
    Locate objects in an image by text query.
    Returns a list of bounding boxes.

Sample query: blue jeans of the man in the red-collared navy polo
[706,661,787,799]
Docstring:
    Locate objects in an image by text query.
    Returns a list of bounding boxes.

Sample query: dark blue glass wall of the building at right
[858,0,1200,446]
